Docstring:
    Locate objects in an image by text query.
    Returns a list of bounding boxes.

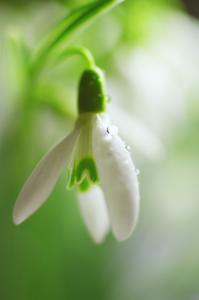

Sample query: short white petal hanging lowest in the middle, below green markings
[78,185,109,244]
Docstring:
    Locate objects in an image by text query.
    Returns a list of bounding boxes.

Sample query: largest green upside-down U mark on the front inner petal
[76,157,99,183]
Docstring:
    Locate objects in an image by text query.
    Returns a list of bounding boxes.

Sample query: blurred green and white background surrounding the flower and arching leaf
[0,0,199,300]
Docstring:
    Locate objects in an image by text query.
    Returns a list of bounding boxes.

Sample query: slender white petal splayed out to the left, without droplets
[13,129,81,225]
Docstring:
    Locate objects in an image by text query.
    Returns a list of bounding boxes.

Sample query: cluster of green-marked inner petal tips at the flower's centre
[68,157,99,192]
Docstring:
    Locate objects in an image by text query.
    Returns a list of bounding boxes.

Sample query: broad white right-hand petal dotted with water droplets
[93,123,139,241]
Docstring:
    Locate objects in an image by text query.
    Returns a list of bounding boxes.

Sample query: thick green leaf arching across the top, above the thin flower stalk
[29,0,124,77]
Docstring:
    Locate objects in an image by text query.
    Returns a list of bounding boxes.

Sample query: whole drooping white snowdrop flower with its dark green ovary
[13,67,139,243]
